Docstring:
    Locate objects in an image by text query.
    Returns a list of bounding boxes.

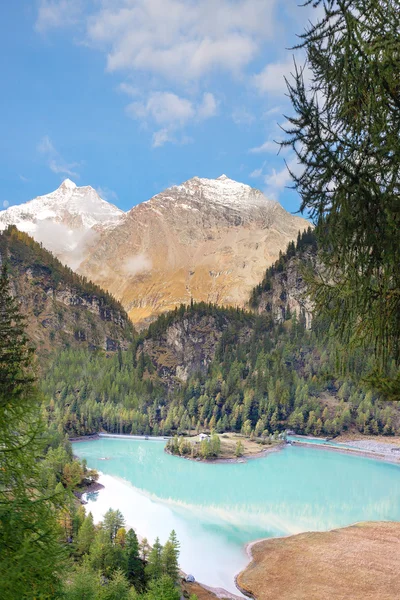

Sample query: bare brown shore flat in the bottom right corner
[235,521,400,600]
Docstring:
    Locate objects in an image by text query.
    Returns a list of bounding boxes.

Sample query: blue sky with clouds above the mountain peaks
[0,0,313,211]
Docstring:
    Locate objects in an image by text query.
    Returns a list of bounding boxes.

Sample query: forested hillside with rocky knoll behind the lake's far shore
[43,232,400,437]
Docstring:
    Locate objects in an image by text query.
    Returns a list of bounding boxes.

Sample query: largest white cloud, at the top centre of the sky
[87,0,276,81]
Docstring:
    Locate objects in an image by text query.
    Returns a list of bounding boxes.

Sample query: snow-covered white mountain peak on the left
[0,179,124,269]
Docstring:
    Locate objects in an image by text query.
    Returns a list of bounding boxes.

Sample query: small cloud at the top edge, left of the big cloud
[35,0,83,33]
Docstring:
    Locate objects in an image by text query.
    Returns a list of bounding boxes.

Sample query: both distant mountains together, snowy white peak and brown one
[0,175,309,328]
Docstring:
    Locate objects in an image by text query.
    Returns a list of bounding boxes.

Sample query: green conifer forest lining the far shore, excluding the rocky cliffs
[44,313,399,440]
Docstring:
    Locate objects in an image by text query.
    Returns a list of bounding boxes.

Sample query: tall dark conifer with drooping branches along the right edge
[284,0,400,400]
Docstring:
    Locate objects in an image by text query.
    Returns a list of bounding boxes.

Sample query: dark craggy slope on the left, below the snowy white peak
[0,227,134,356]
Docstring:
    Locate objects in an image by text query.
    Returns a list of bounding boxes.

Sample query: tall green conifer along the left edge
[0,266,63,600]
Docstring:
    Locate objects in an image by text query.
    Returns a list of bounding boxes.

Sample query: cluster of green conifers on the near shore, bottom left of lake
[62,509,180,600]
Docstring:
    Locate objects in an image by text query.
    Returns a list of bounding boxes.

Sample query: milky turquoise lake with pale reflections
[73,438,400,595]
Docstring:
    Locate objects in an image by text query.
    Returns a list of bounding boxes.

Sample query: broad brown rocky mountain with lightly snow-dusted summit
[79,175,308,327]
